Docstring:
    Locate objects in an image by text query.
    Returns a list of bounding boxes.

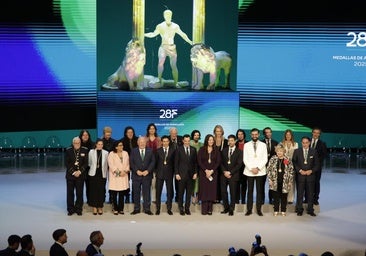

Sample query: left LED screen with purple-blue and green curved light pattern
[0,0,96,132]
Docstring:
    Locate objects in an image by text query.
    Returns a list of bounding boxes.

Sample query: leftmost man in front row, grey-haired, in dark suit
[65,137,89,216]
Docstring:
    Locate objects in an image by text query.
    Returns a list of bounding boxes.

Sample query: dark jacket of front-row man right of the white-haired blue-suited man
[155,147,175,179]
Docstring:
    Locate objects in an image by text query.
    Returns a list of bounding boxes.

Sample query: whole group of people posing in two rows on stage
[65,123,327,216]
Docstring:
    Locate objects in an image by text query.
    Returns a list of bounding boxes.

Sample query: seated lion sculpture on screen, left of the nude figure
[107,39,146,91]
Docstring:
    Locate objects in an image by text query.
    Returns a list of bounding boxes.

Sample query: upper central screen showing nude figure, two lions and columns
[97,0,238,91]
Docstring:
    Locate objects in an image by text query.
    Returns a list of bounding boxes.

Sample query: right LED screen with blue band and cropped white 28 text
[237,0,366,134]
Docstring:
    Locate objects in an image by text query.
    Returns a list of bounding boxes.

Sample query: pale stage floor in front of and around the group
[0,155,366,256]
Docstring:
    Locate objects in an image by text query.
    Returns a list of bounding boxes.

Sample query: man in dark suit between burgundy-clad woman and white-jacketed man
[220,134,243,216]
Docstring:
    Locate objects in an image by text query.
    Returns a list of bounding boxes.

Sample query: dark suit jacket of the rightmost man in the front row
[292,148,319,179]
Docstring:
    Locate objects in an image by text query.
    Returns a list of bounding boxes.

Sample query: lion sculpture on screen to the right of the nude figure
[190,44,232,90]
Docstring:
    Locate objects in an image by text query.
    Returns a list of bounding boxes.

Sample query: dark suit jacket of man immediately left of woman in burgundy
[174,146,198,180]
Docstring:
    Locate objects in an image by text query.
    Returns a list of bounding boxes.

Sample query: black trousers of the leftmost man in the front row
[66,177,85,213]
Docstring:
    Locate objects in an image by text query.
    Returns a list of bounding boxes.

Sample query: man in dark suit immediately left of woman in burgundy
[174,134,198,215]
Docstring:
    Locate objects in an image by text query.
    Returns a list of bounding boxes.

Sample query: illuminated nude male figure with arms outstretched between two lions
[145,10,192,88]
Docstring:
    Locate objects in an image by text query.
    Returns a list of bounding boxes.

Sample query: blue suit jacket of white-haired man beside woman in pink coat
[130,147,155,179]
